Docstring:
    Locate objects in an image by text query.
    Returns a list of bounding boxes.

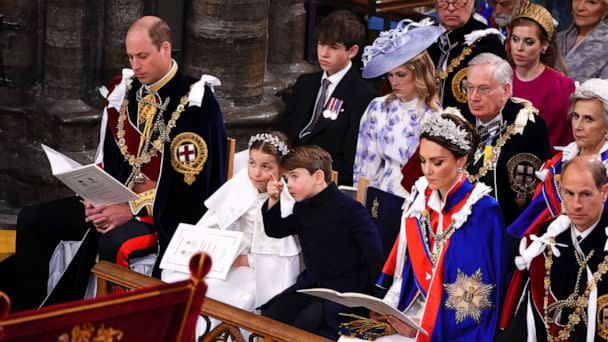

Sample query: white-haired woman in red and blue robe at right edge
[508,78,608,238]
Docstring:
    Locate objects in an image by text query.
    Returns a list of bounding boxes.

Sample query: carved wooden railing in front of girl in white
[92,261,329,342]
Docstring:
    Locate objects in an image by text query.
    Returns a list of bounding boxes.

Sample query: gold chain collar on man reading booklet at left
[116,86,188,189]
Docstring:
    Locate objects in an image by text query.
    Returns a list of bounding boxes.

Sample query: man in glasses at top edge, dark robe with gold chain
[427,0,505,115]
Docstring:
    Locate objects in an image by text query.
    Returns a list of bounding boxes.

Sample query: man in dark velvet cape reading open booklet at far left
[2,17,226,309]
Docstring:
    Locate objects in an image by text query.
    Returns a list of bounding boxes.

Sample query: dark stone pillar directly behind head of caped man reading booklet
[102,0,144,84]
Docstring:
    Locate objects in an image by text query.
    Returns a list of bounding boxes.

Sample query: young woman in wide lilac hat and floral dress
[353,20,442,196]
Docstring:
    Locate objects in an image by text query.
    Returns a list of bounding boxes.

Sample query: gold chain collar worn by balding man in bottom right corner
[543,238,608,342]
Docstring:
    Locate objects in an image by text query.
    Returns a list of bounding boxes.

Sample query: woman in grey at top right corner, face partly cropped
[557,0,608,82]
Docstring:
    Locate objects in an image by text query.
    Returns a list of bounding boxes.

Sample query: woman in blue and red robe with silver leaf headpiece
[344,113,509,341]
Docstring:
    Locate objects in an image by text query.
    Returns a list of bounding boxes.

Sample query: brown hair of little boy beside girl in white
[281,145,332,183]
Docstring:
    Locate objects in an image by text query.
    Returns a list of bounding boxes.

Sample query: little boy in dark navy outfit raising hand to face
[261,146,384,340]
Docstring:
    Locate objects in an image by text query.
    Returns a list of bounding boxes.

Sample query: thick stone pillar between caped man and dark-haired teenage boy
[184,0,268,107]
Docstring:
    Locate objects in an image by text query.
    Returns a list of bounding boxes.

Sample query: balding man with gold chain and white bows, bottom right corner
[501,156,608,341]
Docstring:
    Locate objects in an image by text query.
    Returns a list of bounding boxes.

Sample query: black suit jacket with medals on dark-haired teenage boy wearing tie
[279,65,376,185]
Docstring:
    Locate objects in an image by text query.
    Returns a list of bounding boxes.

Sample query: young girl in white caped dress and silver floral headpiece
[162,132,300,334]
